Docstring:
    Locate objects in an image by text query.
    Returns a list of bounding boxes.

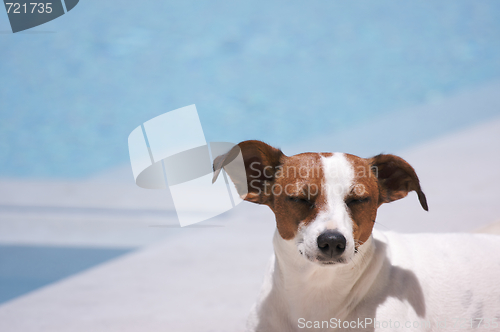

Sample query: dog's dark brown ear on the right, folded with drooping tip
[368,154,429,211]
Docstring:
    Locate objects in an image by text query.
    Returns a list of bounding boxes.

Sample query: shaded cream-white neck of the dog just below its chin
[273,231,383,319]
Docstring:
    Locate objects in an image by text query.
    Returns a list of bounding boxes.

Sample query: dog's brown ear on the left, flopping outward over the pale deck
[213,140,285,204]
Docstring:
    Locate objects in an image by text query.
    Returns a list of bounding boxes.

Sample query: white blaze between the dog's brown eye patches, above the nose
[321,153,354,231]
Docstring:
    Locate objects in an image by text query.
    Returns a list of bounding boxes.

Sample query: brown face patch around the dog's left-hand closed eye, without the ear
[269,153,326,240]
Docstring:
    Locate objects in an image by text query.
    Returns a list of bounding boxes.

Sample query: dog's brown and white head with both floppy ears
[214,141,428,265]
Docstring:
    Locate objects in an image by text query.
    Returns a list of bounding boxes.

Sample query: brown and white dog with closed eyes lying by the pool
[214,140,500,332]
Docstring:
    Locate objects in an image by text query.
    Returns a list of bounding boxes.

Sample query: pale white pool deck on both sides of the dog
[0,96,500,332]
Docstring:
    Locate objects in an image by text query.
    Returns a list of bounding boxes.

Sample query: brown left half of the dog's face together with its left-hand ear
[214,140,331,240]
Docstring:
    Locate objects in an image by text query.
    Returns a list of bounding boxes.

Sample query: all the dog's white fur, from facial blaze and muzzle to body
[247,154,500,332]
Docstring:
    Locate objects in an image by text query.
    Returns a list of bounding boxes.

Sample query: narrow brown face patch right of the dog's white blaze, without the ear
[345,154,380,248]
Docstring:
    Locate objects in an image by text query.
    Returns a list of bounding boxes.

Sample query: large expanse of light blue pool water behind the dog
[0,0,500,178]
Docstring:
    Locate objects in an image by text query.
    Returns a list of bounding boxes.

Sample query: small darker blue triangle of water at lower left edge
[0,245,130,304]
